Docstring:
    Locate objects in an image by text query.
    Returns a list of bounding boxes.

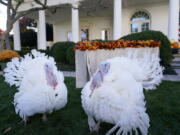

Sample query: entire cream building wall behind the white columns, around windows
[54,2,168,42]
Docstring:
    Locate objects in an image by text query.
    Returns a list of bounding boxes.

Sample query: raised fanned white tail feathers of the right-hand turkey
[127,50,164,90]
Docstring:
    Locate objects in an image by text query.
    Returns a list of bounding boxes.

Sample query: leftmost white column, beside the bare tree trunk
[13,20,21,51]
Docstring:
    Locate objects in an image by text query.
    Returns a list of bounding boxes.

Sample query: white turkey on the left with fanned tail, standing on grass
[4,50,67,122]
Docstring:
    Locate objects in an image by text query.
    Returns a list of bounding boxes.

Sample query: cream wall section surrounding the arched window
[122,2,168,35]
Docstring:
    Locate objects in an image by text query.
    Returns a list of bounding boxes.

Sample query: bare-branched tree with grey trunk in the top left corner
[0,0,48,50]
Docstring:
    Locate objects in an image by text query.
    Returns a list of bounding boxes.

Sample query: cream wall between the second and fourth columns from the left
[53,17,112,42]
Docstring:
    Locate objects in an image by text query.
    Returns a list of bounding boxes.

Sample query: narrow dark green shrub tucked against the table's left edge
[66,46,75,65]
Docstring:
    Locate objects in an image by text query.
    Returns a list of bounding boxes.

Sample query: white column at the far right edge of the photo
[168,0,179,41]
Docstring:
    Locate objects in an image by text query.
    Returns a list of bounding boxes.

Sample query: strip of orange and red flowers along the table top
[75,40,161,51]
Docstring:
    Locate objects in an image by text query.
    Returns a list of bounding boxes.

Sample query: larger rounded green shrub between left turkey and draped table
[50,42,75,63]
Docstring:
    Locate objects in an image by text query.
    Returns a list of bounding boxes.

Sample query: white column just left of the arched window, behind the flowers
[113,0,122,40]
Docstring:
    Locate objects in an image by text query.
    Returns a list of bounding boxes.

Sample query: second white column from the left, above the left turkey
[38,10,47,50]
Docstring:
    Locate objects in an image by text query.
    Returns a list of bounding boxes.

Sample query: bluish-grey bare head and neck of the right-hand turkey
[90,63,110,96]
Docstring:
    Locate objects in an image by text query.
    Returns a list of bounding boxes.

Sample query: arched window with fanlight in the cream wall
[131,11,150,33]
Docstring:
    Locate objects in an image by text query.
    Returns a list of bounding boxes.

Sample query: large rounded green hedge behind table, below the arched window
[121,31,173,68]
